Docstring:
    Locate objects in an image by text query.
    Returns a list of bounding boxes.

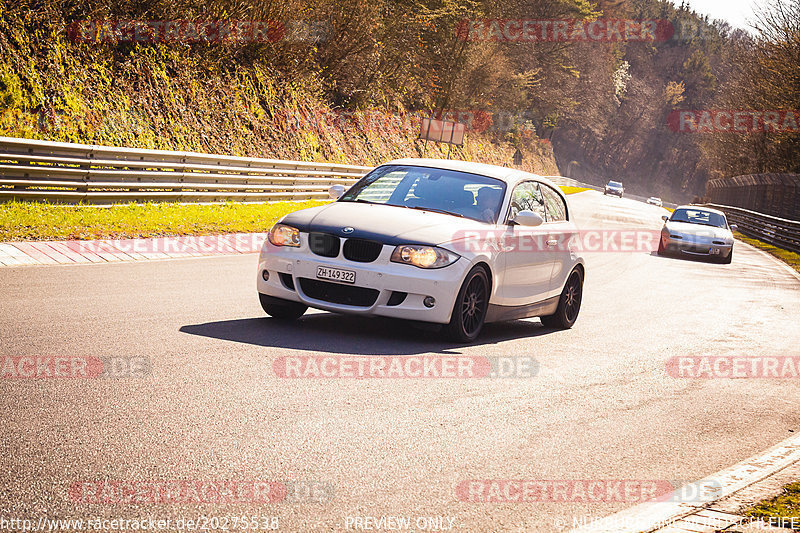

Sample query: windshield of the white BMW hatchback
[339,165,506,224]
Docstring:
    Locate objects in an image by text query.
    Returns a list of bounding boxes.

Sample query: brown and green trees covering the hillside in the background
[4,0,800,196]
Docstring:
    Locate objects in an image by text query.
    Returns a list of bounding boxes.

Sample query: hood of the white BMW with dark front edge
[282,202,494,245]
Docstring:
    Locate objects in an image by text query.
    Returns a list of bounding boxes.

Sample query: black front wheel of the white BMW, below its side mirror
[446,266,489,343]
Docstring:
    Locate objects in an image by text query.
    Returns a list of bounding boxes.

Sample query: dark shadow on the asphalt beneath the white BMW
[180,313,555,355]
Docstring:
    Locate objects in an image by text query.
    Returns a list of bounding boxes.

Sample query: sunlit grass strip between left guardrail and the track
[0,201,325,241]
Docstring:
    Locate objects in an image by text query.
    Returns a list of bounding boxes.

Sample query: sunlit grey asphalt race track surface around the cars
[0,192,800,531]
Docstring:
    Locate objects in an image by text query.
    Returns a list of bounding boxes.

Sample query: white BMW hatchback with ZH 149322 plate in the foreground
[257,159,585,342]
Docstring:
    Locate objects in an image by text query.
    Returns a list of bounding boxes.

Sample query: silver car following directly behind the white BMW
[658,205,736,263]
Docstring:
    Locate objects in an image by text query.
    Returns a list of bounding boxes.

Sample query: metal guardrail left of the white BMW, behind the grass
[0,137,371,204]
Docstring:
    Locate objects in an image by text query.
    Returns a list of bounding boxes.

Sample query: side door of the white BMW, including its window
[498,181,555,306]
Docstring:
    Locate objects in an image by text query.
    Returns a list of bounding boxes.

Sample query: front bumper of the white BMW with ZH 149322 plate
[257,242,471,324]
